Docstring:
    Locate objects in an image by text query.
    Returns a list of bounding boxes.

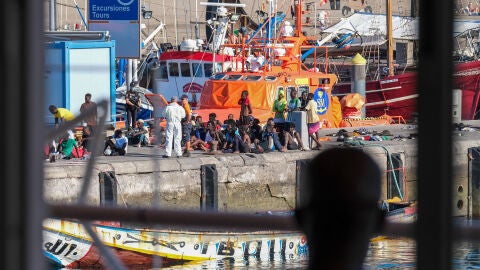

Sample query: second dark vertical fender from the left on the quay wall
[200,164,218,211]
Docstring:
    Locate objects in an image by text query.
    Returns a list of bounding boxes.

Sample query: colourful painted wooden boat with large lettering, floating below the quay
[43,219,308,269]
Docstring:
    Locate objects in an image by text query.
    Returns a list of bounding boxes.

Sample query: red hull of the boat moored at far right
[332,61,480,120]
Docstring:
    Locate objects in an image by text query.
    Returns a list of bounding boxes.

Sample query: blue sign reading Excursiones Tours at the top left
[88,0,140,59]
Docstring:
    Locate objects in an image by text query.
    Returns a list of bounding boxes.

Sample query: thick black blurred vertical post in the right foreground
[416,0,454,270]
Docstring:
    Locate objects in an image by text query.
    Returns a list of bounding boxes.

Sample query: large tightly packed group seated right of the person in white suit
[184,112,306,153]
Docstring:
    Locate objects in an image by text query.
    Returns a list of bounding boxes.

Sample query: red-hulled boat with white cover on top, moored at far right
[318,13,480,120]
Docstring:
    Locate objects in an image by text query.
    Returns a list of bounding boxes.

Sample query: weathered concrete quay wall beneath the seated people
[44,121,480,216]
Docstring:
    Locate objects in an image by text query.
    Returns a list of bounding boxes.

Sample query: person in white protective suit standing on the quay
[162,96,185,158]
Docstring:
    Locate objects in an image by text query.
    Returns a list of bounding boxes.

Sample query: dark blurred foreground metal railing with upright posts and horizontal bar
[0,0,468,269]
